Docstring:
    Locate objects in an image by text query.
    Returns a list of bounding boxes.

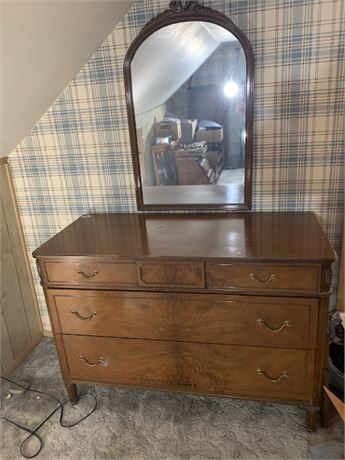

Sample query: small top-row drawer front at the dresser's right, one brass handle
[206,263,319,291]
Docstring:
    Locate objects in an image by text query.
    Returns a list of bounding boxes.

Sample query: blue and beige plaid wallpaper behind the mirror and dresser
[9,0,345,330]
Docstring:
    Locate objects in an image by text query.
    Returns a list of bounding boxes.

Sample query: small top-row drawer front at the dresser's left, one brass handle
[44,261,138,285]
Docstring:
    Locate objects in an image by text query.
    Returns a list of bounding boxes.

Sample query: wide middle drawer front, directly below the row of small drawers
[48,290,318,348]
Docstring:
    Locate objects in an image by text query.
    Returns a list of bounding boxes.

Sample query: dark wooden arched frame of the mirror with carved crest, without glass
[123,0,254,211]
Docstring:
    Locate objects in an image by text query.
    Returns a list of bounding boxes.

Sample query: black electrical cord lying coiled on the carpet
[0,375,97,458]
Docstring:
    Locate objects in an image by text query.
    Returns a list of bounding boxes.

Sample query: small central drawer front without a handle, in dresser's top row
[138,262,205,288]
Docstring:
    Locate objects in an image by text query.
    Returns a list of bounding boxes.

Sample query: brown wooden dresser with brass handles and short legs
[33,212,334,429]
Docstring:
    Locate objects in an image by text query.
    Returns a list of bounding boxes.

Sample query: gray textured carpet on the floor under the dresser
[1,339,344,460]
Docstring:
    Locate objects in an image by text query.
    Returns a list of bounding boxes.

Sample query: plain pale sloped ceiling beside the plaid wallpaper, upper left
[0,0,134,156]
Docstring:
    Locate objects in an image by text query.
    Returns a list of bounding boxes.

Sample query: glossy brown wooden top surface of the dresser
[33,212,334,261]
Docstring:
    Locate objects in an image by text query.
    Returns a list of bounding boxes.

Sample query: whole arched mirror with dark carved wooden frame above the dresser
[124,1,253,209]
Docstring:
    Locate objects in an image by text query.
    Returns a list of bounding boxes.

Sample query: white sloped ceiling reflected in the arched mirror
[131,21,236,113]
